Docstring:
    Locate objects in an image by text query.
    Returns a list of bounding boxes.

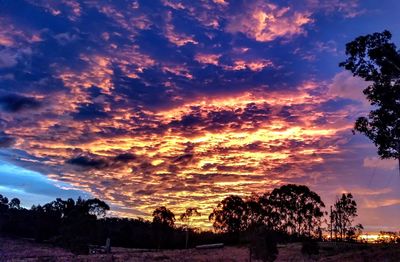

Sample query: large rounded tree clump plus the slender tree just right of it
[209,184,362,240]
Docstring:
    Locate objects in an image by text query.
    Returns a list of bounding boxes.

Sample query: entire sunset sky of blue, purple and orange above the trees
[0,0,400,231]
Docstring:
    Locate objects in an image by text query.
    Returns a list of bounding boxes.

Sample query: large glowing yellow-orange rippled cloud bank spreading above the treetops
[5,82,356,227]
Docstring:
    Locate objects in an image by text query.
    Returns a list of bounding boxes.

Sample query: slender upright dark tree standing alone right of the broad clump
[332,193,362,240]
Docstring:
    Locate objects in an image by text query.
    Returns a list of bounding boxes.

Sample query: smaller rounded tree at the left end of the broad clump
[208,195,247,233]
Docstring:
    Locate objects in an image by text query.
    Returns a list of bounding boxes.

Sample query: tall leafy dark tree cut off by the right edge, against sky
[339,31,400,173]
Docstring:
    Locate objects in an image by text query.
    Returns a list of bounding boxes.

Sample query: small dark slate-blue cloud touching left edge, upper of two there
[0,94,41,113]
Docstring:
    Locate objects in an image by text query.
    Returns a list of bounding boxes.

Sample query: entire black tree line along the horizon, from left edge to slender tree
[0,184,362,253]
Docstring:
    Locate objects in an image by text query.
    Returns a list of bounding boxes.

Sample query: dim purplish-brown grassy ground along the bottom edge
[0,238,400,262]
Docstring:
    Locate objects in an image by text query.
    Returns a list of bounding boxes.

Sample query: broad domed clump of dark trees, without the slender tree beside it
[209,184,325,236]
